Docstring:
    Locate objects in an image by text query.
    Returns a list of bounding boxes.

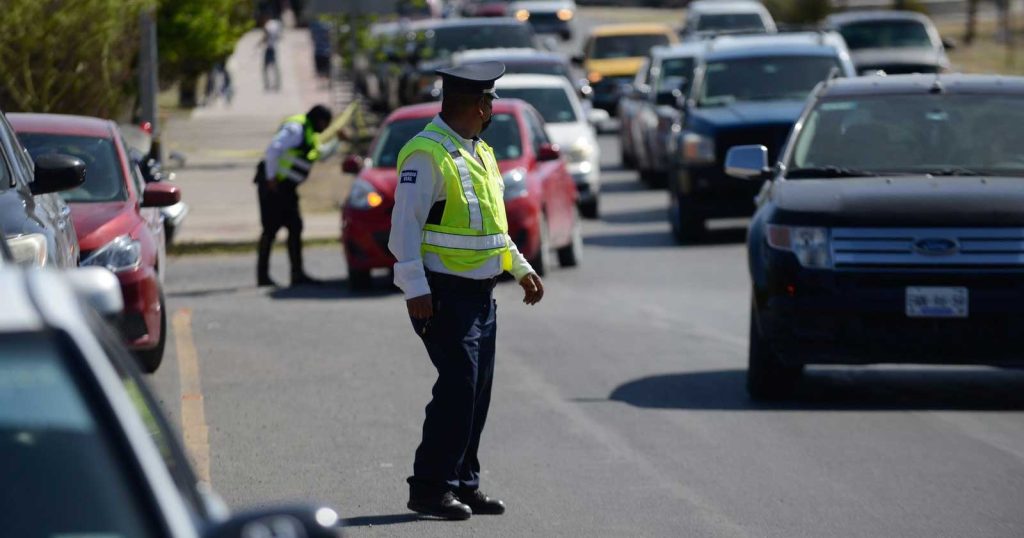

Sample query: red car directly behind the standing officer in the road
[341,99,583,289]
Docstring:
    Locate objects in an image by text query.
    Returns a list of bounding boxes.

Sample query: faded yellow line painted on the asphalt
[172,308,210,485]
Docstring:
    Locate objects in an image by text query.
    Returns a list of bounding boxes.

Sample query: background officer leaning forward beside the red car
[256,105,337,286]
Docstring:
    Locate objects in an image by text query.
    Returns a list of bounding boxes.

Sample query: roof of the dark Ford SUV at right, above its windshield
[820,74,1024,97]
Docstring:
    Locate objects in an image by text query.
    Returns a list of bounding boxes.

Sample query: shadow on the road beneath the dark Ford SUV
[602,368,1024,411]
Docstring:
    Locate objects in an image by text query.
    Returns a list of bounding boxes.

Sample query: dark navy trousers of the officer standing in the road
[409,274,498,498]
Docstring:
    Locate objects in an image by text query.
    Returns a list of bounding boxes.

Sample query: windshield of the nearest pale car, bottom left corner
[0,333,154,538]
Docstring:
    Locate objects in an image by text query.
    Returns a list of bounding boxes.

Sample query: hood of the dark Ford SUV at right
[771,175,1024,226]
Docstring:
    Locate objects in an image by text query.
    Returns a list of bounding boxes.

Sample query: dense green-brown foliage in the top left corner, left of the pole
[0,0,155,117]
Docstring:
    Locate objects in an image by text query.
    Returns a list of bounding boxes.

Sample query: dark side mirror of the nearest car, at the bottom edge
[203,506,341,538]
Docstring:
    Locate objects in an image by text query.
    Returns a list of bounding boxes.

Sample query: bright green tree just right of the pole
[157,0,254,107]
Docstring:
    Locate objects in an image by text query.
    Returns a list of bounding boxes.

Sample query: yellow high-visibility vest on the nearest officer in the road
[398,124,512,273]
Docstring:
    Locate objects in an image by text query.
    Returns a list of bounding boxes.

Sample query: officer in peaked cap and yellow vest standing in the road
[388,61,544,520]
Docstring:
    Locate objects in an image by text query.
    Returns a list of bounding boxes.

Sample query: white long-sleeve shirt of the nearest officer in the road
[388,116,534,299]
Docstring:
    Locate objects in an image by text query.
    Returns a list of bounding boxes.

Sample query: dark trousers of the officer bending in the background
[256,181,304,278]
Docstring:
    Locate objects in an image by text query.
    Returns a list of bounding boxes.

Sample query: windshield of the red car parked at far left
[17,132,128,202]
